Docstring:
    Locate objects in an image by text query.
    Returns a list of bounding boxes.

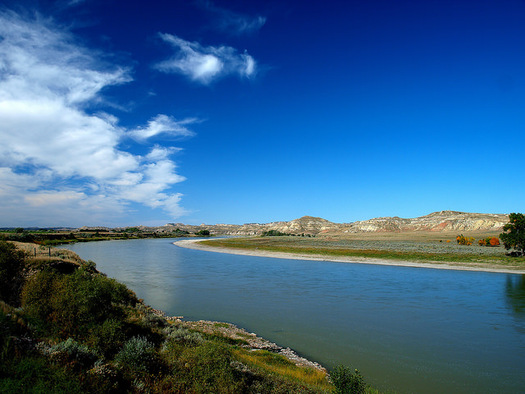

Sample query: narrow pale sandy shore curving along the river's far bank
[173,239,525,274]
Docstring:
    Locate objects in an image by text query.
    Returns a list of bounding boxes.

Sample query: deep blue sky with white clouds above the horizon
[0,0,525,227]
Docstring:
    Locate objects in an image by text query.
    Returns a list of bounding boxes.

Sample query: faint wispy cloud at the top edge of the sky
[198,1,266,34]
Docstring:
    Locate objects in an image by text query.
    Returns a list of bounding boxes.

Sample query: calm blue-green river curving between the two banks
[66,239,525,393]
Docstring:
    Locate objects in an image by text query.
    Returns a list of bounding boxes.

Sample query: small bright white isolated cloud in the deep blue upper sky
[156,33,257,85]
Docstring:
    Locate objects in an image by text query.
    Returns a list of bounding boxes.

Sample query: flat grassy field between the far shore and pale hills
[199,234,525,272]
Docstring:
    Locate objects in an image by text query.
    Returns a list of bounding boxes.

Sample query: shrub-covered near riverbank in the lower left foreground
[0,241,376,393]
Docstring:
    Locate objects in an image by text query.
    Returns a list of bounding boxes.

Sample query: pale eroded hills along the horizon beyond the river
[155,211,509,235]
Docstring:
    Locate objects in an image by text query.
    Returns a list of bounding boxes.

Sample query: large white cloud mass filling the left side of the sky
[0,11,193,225]
